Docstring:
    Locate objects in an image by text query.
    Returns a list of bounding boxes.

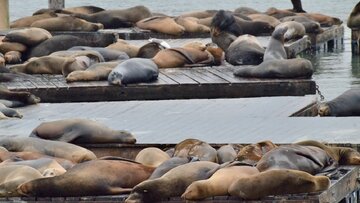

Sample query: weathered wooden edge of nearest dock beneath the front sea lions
[0,166,359,203]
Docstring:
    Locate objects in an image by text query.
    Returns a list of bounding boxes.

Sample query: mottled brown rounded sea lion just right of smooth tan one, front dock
[174,139,218,163]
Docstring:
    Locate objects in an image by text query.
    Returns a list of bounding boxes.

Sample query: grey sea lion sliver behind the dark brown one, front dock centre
[149,157,199,180]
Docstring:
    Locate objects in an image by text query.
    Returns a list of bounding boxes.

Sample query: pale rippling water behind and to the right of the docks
[9,0,360,100]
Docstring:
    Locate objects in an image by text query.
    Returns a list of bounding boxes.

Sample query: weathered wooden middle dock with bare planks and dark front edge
[3,66,315,102]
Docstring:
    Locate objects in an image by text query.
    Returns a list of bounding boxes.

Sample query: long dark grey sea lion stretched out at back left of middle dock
[27,34,113,58]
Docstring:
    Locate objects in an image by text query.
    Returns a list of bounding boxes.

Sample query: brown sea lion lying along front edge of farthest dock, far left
[31,16,104,32]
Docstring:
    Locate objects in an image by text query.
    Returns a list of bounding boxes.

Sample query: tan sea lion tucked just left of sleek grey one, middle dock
[65,61,122,82]
